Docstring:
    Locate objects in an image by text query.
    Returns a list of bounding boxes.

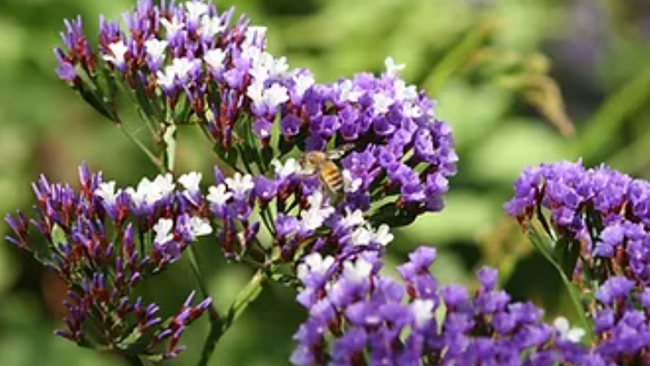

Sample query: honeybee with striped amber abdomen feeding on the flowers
[300,144,354,194]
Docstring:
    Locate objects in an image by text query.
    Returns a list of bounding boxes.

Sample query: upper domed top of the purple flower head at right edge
[506,162,650,285]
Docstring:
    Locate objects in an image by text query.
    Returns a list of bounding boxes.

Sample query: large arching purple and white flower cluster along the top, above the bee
[56,0,458,221]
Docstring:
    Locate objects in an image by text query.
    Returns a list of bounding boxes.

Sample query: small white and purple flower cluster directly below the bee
[206,159,393,263]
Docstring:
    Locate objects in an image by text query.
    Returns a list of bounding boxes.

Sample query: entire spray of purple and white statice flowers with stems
[6,0,650,366]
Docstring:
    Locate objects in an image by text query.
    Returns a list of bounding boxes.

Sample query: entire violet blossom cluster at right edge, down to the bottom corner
[506,161,650,365]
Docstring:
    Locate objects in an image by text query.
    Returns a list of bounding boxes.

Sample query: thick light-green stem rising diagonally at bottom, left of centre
[197,270,266,366]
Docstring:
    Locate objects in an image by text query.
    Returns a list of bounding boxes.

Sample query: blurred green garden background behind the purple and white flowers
[0,0,650,366]
